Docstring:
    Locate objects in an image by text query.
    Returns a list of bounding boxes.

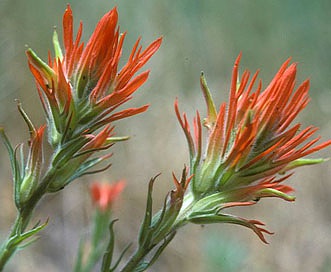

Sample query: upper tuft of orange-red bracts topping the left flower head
[27,5,162,147]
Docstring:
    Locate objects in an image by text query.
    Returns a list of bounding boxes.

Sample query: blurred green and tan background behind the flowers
[0,0,331,272]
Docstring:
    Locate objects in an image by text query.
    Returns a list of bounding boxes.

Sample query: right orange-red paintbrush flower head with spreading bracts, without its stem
[175,55,331,242]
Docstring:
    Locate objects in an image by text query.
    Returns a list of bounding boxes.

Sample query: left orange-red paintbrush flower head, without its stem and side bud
[26,5,162,192]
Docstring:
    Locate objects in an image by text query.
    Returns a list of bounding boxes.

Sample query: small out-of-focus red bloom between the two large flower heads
[90,180,125,211]
